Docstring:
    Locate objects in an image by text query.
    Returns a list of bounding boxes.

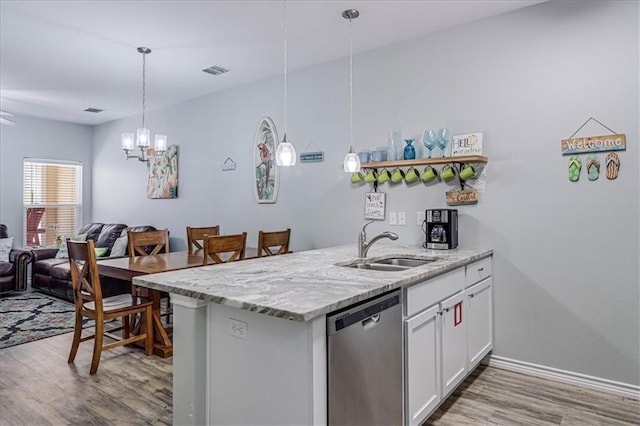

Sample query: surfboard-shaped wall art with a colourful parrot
[253,117,278,204]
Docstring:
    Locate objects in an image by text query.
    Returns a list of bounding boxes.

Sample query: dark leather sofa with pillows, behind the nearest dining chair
[31,223,156,302]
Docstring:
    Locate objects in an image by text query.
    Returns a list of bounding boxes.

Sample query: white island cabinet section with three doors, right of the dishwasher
[404,257,493,426]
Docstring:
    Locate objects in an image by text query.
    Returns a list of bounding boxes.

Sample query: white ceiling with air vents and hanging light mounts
[0,0,542,125]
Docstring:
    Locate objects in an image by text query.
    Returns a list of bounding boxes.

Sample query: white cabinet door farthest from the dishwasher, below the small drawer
[466,277,493,369]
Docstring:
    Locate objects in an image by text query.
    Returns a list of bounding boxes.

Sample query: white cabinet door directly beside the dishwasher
[404,305,440,426]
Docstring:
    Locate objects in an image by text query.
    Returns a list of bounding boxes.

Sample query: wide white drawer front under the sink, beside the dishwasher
[405,268,465,317]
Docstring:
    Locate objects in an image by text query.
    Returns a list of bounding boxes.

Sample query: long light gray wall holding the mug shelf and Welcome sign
[92,1,640,386]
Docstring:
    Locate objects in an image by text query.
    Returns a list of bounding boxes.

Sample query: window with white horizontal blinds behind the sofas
[23,159,82,247]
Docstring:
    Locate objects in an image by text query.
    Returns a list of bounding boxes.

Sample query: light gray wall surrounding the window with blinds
[0,116,93,236]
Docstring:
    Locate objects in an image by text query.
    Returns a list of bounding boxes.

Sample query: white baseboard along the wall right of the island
[482,355,640,399]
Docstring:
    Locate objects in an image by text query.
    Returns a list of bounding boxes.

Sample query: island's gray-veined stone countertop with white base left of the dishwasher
[133,243,492,424]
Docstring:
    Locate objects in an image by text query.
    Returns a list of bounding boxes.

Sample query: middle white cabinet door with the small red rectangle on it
[440,291,468,398]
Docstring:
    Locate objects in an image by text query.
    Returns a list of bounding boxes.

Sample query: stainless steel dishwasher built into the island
[327,290,402,426]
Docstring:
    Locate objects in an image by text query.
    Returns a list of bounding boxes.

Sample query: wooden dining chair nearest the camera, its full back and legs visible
[67,239,153,375]
